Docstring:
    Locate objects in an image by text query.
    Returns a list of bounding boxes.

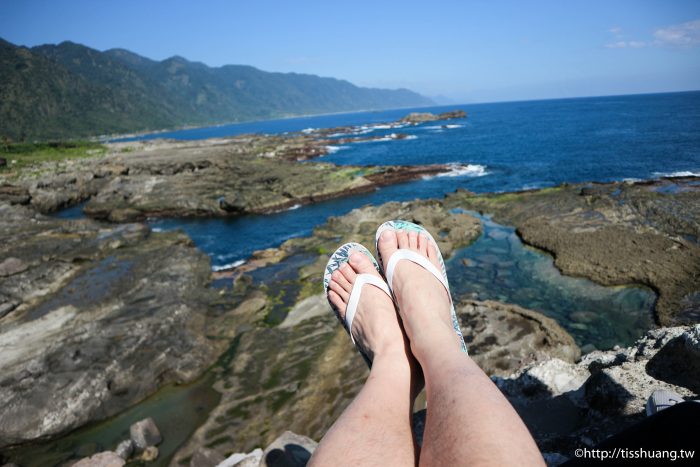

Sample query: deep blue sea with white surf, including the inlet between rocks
[142,92,700,267]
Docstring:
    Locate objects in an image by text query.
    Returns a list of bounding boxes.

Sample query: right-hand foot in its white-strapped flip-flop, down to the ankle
[377,223,466,361]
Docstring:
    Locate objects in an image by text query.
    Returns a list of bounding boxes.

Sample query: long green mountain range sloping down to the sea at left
[0,39,433,140]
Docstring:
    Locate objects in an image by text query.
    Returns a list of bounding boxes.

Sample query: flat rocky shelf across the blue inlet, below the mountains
[0,113,470,222]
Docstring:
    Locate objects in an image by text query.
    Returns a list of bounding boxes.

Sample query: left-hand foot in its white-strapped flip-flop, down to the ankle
[324,244,406,363]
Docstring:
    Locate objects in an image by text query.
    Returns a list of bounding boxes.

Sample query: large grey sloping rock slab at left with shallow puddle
[0,204,235,447]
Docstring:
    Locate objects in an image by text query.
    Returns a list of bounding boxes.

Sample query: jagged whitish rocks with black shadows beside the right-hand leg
[494,325,700,457]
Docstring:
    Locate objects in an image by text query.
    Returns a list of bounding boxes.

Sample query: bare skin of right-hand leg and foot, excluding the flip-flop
[379,231,544,466]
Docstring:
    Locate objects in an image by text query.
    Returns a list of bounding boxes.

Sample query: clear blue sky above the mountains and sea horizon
[0,0,700,102]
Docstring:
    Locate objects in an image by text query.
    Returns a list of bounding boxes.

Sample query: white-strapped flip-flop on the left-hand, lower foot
[323,242,394,368]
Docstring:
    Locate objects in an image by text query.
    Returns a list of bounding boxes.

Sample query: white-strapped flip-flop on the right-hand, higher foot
[374,220,467,353]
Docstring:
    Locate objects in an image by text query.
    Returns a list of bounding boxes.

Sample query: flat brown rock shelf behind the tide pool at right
[445,178,700,326]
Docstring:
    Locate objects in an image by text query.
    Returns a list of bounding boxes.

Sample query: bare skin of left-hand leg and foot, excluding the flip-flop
[309,253,419,467]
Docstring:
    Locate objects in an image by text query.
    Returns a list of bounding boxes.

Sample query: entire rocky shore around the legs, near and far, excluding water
[0,122,700,466]
